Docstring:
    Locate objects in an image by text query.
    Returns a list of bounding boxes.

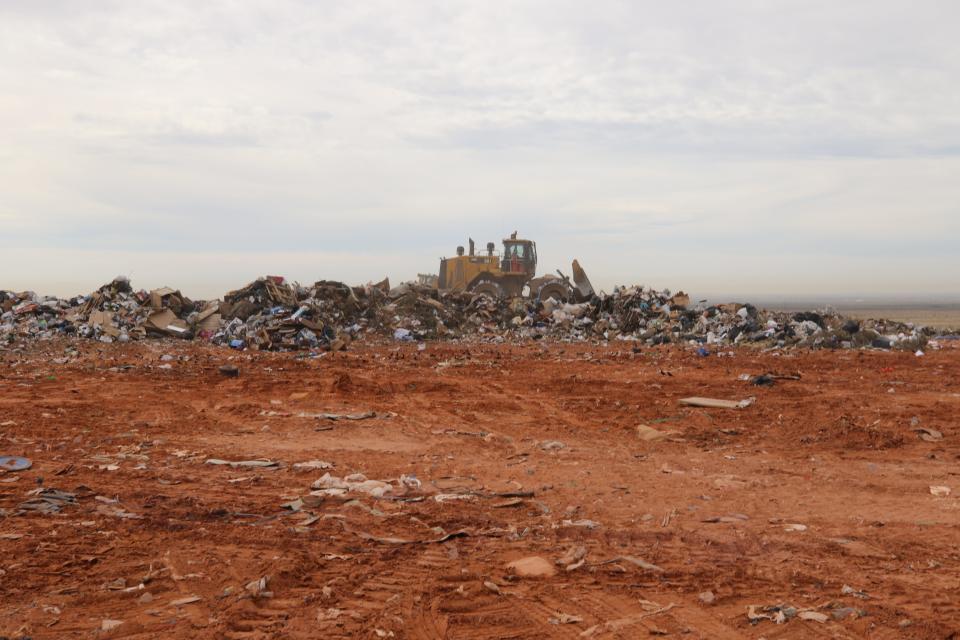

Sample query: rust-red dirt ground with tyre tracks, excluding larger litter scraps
[0,342,960,639]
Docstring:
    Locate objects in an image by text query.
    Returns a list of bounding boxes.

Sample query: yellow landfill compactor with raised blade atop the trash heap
[436,231,594,301]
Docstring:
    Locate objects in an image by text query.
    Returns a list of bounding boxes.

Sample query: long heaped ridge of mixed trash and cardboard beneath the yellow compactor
[0,276,936,355]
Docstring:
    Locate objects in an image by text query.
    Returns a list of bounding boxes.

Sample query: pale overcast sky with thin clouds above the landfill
[0,0,960,298]
